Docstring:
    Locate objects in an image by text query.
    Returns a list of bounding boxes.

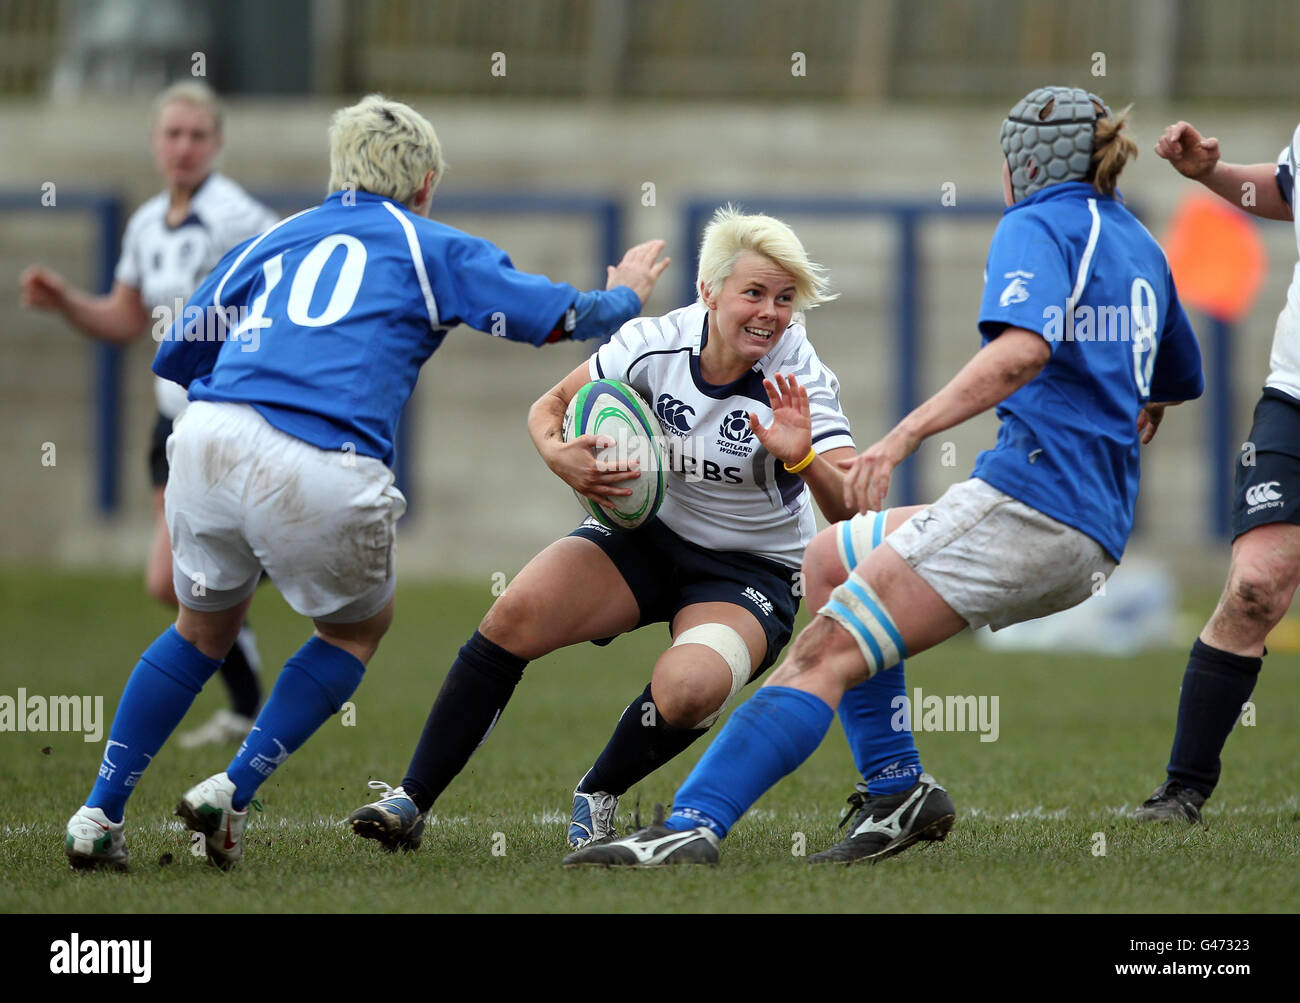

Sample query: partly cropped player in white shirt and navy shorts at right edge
[1134,122,1300,822]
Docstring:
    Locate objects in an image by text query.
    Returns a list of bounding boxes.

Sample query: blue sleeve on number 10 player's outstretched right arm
[436,236,577,344]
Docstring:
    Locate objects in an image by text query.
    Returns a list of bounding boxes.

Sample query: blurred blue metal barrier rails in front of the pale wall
[0,190,1235,537]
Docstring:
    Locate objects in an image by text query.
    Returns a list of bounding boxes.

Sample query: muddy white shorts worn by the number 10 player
[165,400,406,624]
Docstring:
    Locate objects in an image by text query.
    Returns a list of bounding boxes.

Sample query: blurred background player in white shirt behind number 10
[20,81,278,746]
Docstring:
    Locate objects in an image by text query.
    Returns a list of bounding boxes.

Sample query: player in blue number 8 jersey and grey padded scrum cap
[566,87,1203,867]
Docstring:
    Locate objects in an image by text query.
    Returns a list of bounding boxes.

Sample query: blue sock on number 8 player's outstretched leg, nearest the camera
[667,686,835,839]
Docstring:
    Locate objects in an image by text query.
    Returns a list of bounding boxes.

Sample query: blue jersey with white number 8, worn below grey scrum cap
[974,182,1204,561]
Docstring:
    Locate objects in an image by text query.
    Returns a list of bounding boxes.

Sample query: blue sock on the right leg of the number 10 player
[226,637,365,811]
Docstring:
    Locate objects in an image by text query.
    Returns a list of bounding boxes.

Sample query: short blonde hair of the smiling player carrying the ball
[696,203,840,311]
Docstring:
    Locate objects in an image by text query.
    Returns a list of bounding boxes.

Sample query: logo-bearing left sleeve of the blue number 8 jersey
[979,210,1073,352]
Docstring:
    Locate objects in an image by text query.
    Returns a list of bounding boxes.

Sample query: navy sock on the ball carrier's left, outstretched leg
[402,630,528,812]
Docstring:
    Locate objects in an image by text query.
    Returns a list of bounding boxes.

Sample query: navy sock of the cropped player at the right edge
[1167,638,1264,798]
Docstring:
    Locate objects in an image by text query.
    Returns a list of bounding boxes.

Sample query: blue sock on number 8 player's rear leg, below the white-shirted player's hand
[840,661,922,795]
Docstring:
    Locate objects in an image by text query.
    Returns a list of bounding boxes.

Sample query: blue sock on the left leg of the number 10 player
[86,626,221,822]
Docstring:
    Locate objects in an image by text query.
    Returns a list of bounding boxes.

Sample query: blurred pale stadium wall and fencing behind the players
[0,0,1300,587]
